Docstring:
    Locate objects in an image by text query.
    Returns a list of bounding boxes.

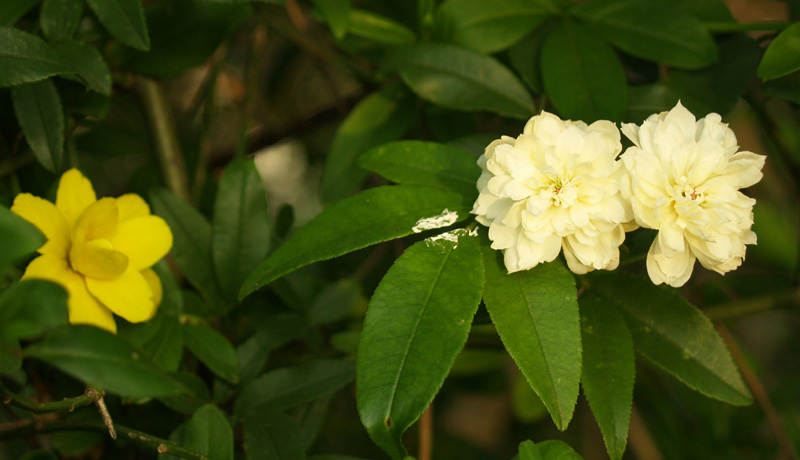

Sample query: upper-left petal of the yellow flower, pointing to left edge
[11,193,69,258]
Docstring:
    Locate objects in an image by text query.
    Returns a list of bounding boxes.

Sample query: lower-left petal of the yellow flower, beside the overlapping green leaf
[22,254,117,334]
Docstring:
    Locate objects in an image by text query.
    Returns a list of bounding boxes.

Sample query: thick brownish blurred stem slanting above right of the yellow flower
[136,77,190,202]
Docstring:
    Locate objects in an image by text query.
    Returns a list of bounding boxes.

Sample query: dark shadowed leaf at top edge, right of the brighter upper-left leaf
[122,0,252,77]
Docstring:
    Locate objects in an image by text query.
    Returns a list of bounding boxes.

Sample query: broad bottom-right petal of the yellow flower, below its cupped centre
[86,270,156,323]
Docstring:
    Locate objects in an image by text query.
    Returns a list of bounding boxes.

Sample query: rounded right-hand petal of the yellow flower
[111,216,172,270]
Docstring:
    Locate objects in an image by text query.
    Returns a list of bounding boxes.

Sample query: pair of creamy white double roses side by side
[472,102,765,287]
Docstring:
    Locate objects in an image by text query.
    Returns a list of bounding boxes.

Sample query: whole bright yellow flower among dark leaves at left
[11,169,172,332]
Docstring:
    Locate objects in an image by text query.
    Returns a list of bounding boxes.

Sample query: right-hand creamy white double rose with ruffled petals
[621,102,765,287]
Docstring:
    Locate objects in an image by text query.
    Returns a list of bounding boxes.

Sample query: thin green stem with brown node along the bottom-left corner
[0,420,209,460]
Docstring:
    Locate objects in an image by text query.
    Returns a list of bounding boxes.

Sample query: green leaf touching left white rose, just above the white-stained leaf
[358,141,481,201]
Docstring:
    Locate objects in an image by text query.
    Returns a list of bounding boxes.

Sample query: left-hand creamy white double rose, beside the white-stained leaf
[472,112,633,274]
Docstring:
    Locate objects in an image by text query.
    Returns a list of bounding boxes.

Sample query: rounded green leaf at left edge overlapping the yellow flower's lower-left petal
[0,279,67,340]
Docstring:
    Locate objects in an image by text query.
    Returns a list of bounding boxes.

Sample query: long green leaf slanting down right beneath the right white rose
[590,273,752,406]
